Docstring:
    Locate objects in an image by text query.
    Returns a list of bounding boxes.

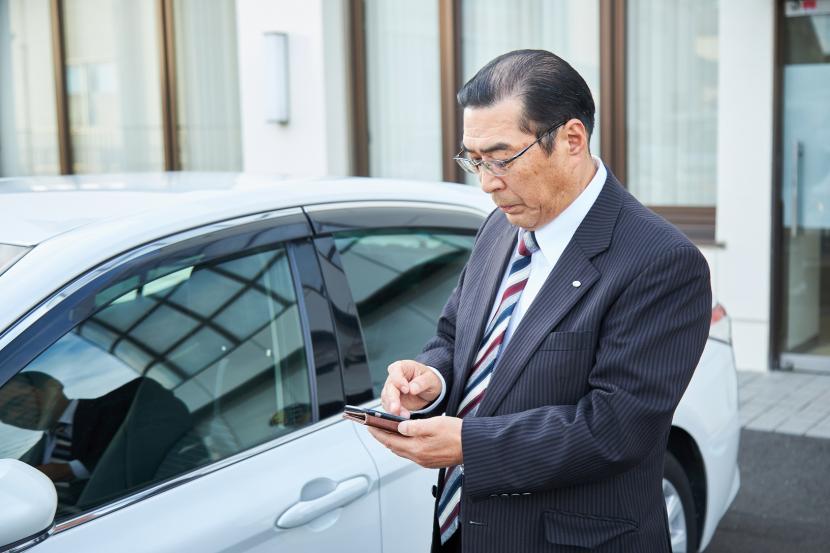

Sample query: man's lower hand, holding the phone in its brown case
[367,416,464,469]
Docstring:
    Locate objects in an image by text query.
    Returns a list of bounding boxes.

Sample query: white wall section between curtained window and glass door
[716,0,775,370]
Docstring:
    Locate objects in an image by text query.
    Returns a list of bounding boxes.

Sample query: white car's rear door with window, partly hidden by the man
[307,202,484,553]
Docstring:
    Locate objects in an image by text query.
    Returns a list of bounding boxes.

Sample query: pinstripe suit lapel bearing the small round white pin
[474,170,625,417]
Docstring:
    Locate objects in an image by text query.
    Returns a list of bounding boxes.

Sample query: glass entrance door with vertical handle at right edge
[779,0,830,372]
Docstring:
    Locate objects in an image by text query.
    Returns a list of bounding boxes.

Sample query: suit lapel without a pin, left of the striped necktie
[447,226,519,414]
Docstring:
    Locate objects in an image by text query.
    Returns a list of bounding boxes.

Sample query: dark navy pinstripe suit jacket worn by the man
[418,171,711,553]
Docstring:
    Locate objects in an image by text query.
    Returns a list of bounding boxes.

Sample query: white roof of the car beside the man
[0,173,494,335]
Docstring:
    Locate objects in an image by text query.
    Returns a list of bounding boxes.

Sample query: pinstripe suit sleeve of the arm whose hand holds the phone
[462,245,712,498]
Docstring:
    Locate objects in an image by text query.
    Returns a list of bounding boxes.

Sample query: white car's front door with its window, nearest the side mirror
[0,209,381,553]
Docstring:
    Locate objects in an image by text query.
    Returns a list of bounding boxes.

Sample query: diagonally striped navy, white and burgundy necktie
[438,229,539,544]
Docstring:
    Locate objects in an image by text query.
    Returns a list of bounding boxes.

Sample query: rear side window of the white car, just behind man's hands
[335,230,474,397]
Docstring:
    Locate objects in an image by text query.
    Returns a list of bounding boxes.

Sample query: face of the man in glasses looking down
[462,98,572,230]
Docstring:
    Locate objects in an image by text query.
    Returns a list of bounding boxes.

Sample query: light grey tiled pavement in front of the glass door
[738,371,830,438]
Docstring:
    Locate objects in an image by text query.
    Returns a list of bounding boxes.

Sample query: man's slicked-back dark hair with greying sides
[457,50,595,154]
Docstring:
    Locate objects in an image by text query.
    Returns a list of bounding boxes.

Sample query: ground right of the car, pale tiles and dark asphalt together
[706,371,830,553]
